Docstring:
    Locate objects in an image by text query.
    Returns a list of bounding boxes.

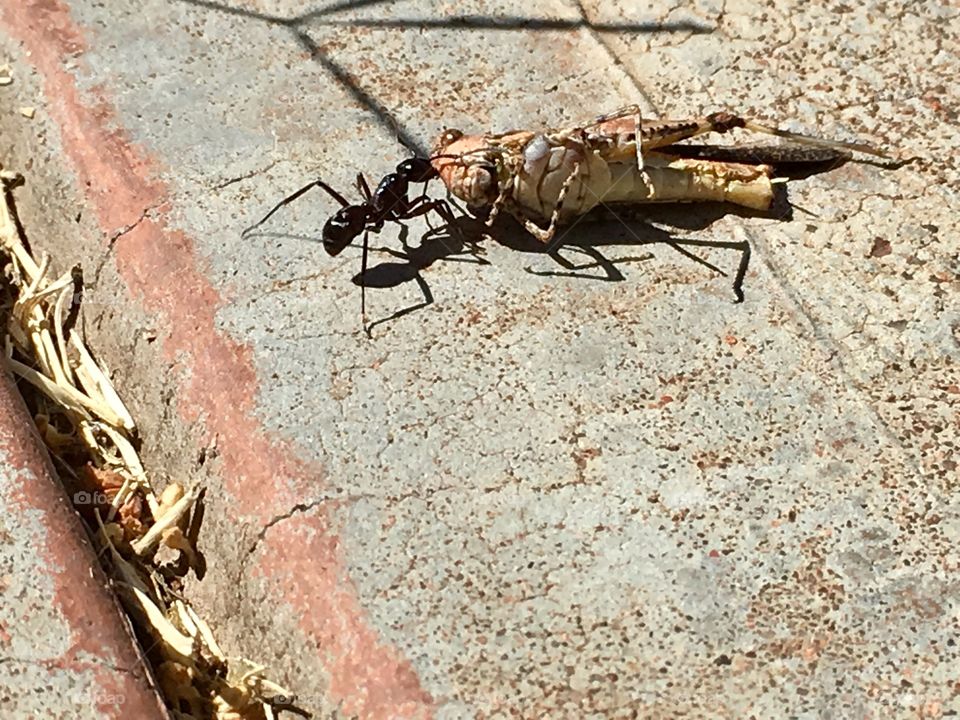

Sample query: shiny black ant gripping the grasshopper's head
[241,157,455,334]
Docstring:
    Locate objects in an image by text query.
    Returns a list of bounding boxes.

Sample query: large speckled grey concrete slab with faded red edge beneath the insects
[2,0,960,718]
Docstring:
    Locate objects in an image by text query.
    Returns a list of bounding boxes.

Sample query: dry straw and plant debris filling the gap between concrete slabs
[0,166,306,720]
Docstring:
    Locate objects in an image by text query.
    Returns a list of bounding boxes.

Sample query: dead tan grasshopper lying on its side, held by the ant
[432,105,886,246]
